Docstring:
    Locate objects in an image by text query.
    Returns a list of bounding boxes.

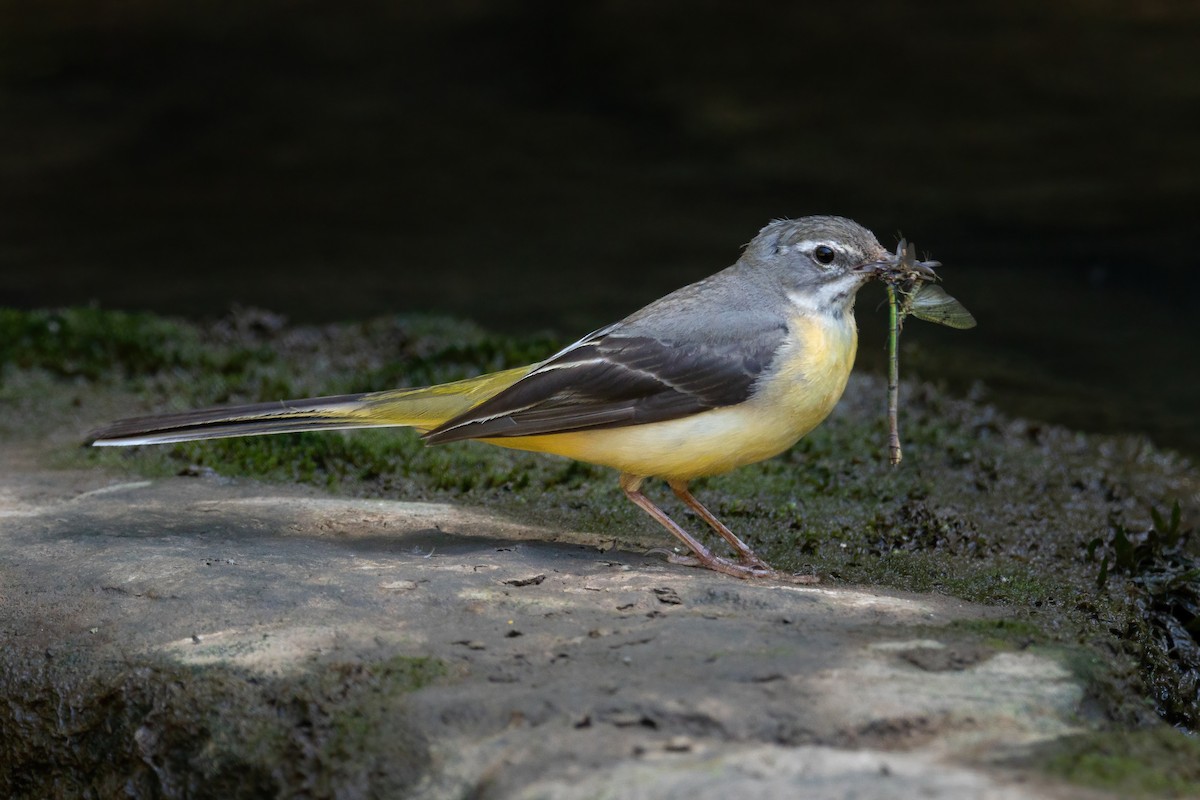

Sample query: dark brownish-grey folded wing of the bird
[425,320,787,444]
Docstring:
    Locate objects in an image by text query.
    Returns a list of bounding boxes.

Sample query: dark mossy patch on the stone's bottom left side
[0,652,445,798]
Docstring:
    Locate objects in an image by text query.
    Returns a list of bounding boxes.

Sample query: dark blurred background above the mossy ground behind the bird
[0,0,1200,455]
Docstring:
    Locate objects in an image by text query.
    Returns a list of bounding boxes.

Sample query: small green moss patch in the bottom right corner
[1037,726,1200,798]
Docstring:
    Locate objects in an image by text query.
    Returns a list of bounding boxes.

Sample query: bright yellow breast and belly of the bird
[484,314,858,480]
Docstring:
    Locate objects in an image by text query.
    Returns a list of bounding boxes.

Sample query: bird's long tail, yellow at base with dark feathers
[84,367,532,447]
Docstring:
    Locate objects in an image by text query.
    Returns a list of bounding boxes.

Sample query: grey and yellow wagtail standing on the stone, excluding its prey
[90,216,931,578]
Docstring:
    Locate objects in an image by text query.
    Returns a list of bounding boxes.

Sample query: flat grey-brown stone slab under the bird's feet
[0,457,1084,798]
